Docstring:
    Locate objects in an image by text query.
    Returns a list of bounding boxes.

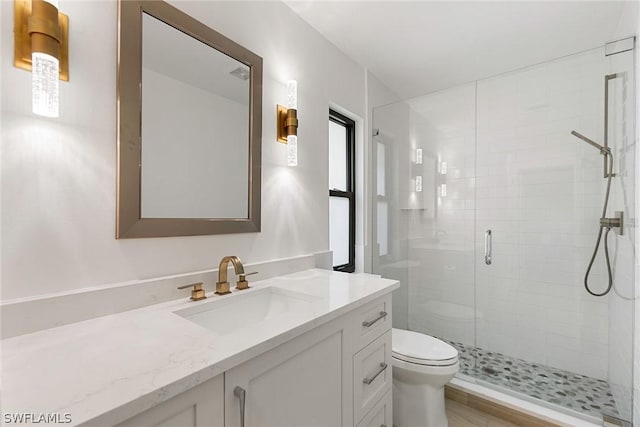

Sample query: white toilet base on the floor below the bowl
[393,380,449,427]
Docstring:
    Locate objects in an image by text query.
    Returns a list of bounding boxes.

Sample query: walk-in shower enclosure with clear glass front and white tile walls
[372,40,636,421]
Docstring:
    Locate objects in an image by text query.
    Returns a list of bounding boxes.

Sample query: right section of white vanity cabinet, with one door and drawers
[224,296,391,427]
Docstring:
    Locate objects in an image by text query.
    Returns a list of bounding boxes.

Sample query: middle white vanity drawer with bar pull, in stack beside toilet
[353,330,392,424]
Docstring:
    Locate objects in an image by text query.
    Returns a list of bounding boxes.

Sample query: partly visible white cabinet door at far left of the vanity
[118,375,224,427]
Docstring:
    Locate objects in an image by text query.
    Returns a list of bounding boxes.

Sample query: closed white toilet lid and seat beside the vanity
[392,328,458,366]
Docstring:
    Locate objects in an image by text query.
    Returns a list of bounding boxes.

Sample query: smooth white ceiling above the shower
[285,0,625,98]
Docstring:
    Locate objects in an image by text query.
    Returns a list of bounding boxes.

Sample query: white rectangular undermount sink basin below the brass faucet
[174,287,317,335]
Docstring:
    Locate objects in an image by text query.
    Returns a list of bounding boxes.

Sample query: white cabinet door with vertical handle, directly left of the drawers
[225,319,353,427]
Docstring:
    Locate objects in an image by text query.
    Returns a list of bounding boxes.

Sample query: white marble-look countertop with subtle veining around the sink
[0,269,399,425]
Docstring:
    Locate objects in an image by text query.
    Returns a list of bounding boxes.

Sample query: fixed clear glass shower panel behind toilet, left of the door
[373,83,476,354]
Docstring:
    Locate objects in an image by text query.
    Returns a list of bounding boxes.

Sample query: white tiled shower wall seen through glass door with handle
[476,49,616,379]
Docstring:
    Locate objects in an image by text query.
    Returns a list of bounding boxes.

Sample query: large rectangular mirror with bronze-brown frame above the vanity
[116,0,262,238]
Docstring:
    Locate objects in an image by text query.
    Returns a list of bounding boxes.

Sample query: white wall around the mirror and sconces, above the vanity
[0,0,365,300]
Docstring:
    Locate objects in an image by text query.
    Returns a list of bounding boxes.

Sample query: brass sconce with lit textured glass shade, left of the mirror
[13,0,69,117]
